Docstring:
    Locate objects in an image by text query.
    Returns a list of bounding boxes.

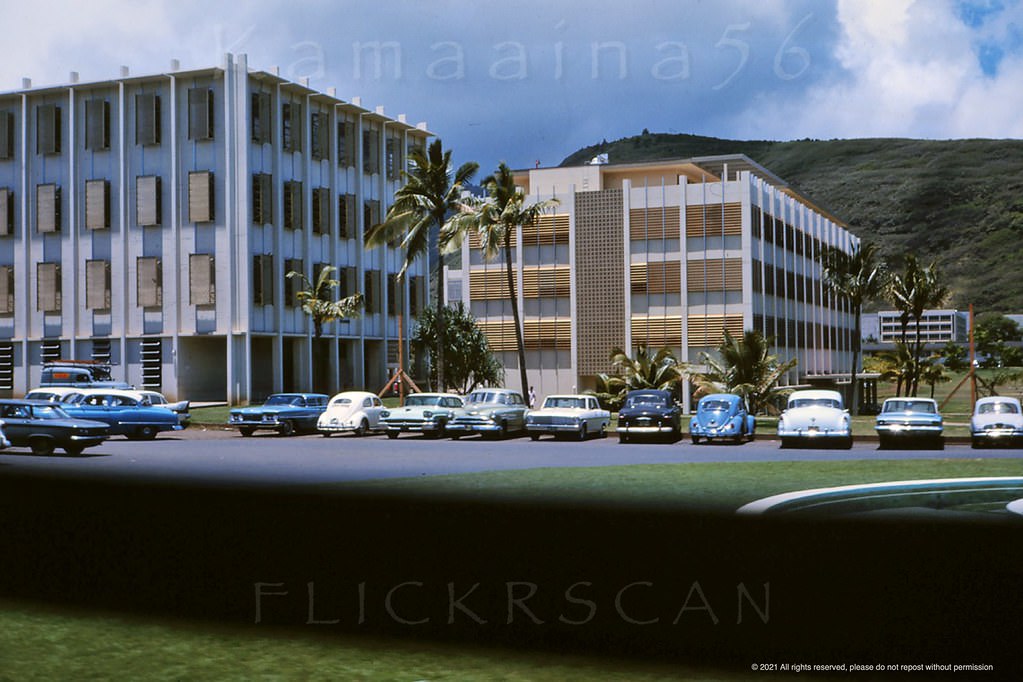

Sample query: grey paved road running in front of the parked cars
[0,427,1023,486]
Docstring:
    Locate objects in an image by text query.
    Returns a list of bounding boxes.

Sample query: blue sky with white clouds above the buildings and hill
[0,0,1023,172]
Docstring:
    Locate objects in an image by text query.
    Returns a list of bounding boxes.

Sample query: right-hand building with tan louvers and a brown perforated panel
[445,155,858,403]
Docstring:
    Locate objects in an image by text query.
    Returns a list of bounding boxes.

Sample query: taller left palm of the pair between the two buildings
[365,139,480,391]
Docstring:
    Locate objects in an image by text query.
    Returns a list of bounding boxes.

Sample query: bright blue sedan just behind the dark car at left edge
[60,389,181,441]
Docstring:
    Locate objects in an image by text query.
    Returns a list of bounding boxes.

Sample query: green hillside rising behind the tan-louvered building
[562,133,1023,313]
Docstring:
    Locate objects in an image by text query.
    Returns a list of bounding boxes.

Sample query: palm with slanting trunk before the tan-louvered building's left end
[442,162,560,396]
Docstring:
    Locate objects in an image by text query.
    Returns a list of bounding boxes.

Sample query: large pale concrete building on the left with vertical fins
[0,54,430,402]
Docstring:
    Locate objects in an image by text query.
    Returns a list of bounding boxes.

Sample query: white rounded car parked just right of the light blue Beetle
[777,391,852,449]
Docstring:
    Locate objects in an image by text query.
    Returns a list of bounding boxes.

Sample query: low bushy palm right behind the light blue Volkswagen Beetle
[691,329,797,414]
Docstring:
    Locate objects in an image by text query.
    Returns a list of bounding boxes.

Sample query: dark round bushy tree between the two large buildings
[410,301,504,394]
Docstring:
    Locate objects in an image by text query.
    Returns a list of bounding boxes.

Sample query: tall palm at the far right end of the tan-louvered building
[821,242,886,415]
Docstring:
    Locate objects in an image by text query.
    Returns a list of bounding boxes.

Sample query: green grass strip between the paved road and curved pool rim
[333,458,1023,511]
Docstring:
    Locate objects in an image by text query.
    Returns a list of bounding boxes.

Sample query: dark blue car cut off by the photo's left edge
[0,399,110,456]
